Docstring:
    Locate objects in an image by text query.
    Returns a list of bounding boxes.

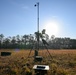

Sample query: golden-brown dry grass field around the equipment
[0,50,76,75]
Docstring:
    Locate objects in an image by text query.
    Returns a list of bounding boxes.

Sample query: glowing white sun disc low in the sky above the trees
[44,21,59,37]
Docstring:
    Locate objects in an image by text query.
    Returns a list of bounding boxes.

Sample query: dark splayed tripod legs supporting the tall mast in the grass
[26,38,53,61]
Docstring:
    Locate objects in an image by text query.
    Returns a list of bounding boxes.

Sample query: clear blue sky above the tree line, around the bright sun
[0,0,76,38]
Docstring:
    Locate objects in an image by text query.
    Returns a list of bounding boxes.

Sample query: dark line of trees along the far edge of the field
[0,32,76,49]
